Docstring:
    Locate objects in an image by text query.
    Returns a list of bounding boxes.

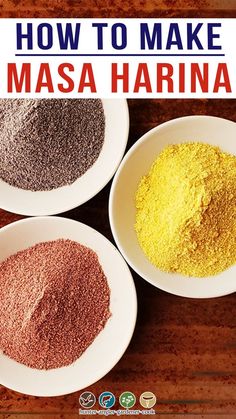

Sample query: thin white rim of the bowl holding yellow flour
[108,115,236,299]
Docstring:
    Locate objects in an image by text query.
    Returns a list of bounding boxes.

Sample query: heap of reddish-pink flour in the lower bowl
[0,239,110,369]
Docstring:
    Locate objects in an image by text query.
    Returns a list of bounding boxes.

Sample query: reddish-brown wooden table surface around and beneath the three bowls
[0,0,236,419]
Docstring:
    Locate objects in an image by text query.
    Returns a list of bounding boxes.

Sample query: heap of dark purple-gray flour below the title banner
[0,99,105,191]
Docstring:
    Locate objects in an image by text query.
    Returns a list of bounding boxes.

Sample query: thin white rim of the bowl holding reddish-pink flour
[0,216,138,397]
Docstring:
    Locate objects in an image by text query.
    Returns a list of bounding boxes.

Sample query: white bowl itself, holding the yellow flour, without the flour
[109,116,236,298]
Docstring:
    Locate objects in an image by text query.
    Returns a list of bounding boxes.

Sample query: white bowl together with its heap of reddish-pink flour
[0,217,137,396]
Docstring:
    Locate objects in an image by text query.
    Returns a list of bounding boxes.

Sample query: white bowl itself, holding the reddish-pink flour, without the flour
[0,217,137,396]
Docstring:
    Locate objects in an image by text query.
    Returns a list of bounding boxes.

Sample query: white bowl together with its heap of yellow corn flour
[109,116,236,298]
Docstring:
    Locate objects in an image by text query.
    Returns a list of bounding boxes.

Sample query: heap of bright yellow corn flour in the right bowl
[135,143,236,277]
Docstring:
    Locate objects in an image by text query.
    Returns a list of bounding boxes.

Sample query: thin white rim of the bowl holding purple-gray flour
[0,98,130,217]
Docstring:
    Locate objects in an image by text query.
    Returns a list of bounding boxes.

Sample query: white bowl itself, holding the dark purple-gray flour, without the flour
[0,99,129,216]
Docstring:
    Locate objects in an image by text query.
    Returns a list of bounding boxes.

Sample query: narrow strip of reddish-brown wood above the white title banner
[0,0,236,18]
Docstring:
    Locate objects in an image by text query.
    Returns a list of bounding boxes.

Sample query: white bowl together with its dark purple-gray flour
[0,99,129,216]
